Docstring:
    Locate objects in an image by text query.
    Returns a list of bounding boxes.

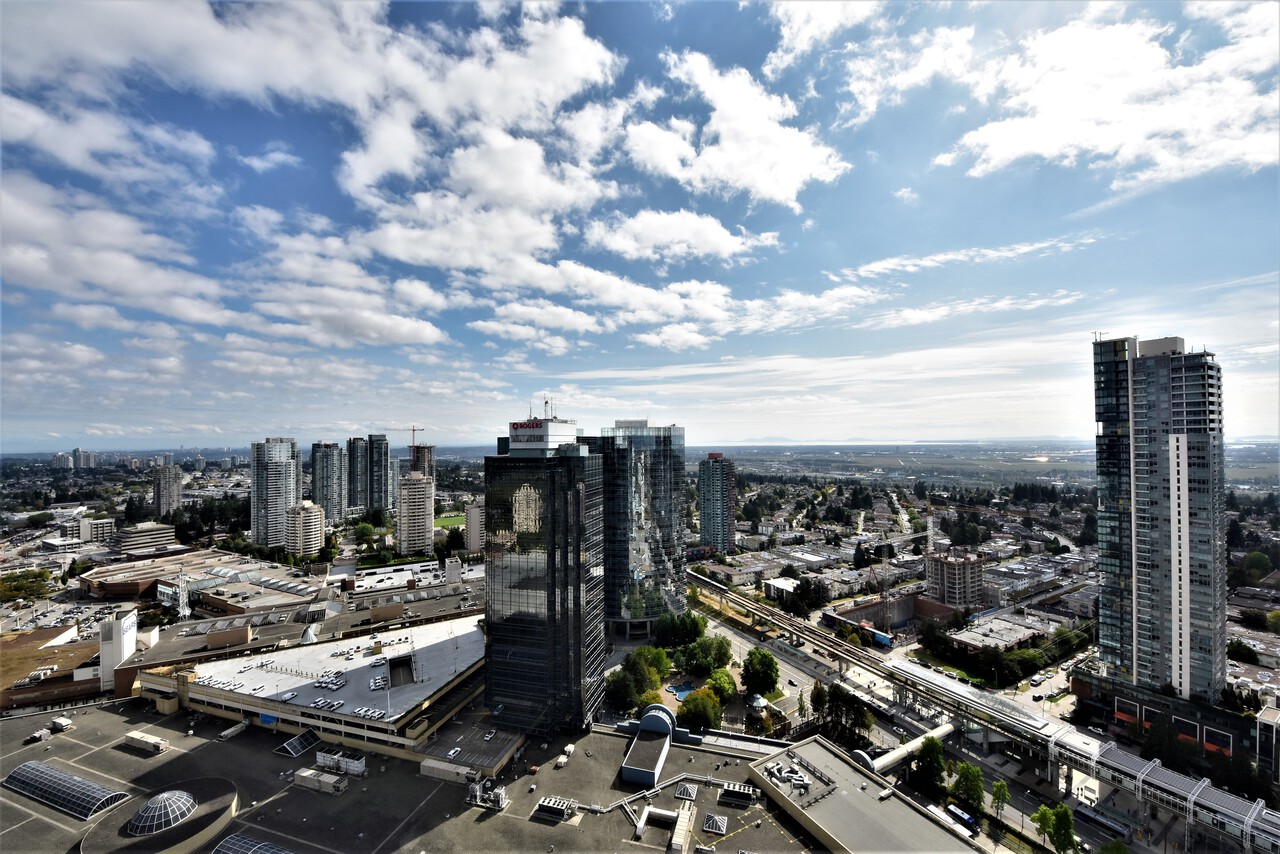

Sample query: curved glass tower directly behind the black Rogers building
[582,419,686,638]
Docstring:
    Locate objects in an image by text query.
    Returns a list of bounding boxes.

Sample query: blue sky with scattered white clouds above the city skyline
[0,0,1280,451]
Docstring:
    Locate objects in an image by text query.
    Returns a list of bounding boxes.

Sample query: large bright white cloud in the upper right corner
[940,4,1280,192]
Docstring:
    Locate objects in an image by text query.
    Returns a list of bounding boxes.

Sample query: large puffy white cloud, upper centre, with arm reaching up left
[626,52,850,213]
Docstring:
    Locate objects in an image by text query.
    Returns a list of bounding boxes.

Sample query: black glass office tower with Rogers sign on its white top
[484,417,605,736]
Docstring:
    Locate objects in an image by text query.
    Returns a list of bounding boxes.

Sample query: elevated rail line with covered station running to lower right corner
[690,572,1280,854]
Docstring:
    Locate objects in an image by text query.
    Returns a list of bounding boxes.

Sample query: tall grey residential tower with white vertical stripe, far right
[1093,338,1226,702]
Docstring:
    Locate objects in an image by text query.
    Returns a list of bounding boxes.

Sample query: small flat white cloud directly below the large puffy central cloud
[585,210,778,262]
